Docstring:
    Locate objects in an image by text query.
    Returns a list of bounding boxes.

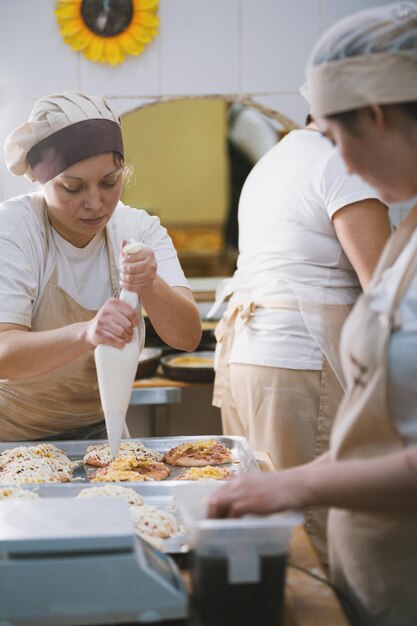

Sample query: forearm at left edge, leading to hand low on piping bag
[0,322,93,380]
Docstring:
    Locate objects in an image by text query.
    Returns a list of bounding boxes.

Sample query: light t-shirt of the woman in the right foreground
[369,227,417,446]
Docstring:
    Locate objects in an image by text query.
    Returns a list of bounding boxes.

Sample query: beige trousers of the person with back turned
[221,360,343,564]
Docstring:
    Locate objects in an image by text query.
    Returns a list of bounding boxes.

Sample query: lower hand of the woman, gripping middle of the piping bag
[86,298,139,348]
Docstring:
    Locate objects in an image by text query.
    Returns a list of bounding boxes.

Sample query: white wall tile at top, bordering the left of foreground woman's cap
[241,0,320,93]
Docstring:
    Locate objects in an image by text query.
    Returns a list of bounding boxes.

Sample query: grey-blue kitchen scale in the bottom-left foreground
[0,497,188,626]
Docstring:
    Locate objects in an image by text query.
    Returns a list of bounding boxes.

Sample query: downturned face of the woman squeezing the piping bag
[43,152,123,248]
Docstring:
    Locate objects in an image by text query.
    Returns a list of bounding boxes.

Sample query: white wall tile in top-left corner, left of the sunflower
[0,0,78,98]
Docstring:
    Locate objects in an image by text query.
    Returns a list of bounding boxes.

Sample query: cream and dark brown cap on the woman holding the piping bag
[4,91,123,183]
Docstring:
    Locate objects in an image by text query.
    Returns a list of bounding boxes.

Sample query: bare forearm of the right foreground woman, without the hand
[300,446,417,513]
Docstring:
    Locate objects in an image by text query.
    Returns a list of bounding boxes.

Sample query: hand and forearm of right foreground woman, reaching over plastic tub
[208,445,417,517]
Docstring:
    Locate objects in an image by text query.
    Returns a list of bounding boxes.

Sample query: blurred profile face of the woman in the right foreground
[315,108,417,202]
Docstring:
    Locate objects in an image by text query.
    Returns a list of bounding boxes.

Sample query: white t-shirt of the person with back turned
[229,129,378,370]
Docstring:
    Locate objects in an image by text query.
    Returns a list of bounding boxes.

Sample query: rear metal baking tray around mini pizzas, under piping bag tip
[0,435,260,482]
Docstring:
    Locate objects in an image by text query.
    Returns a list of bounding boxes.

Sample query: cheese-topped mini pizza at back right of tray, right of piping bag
[163,438,232,467]
